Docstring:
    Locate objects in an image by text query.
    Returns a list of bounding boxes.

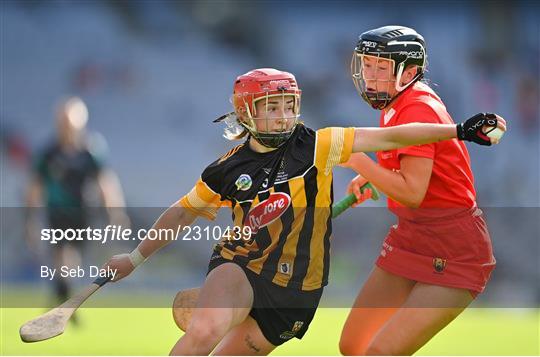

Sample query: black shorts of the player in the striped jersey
[206,253,323,346]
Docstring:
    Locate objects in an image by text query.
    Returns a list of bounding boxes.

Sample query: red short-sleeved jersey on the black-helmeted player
[377,82,476,220]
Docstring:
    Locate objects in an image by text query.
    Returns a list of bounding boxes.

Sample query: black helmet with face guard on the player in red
[351,26,427,109]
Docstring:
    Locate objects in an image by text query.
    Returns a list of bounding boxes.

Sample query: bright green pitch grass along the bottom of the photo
[0,308,540,355]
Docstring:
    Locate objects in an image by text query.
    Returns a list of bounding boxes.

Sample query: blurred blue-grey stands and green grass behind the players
[0,0,540,355]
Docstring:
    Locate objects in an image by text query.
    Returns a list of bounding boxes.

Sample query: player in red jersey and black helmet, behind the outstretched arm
[340,26,501,355]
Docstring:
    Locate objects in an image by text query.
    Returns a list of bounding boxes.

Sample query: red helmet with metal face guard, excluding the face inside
[232,68,302,147]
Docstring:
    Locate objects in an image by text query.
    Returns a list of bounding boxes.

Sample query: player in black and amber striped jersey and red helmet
[105,68,504,355]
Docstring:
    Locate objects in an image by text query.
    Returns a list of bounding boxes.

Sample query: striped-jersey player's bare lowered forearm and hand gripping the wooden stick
[102,201,197,281]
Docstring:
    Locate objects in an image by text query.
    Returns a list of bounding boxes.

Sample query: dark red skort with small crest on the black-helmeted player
[376,208,495,297]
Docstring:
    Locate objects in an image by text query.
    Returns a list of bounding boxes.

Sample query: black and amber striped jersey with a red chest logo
[180,125,354,290]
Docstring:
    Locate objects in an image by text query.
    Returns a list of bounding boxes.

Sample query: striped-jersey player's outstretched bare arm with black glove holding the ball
[353,113,506,152]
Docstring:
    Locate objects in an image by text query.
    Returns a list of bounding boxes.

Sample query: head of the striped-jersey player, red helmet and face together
[233,68,302,148]
